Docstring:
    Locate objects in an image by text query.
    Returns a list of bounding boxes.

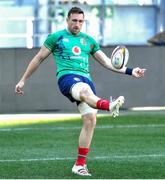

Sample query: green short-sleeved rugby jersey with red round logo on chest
[44,29,100,79]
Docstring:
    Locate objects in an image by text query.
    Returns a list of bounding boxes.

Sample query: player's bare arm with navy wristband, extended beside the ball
[93,50,146,78]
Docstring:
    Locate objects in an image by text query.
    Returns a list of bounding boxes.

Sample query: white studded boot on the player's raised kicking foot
[110,96,125,117]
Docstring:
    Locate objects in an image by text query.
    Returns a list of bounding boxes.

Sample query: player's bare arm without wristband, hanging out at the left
[15,46,51,95]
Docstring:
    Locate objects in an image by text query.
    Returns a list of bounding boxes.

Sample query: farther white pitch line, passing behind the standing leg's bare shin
[0,124,165,132]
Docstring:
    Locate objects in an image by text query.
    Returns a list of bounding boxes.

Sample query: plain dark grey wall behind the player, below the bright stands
[0,46,165,113]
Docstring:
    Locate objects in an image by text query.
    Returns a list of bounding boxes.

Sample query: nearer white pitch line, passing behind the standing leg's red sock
[0,154,165,163]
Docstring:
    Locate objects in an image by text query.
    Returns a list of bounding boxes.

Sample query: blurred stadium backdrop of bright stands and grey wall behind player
[0,0,165,113]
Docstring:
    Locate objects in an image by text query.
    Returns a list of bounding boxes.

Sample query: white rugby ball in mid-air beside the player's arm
[111,46,129,69]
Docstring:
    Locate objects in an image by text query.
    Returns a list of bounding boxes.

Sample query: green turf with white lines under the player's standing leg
[0,113,165,179]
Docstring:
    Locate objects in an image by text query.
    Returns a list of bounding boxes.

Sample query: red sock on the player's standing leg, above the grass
[76,147,89,166]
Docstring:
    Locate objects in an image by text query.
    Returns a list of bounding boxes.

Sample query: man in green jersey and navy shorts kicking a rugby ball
[15,7,145,176]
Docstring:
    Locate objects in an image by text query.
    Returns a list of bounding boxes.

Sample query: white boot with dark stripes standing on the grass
[72,164,91,176]
